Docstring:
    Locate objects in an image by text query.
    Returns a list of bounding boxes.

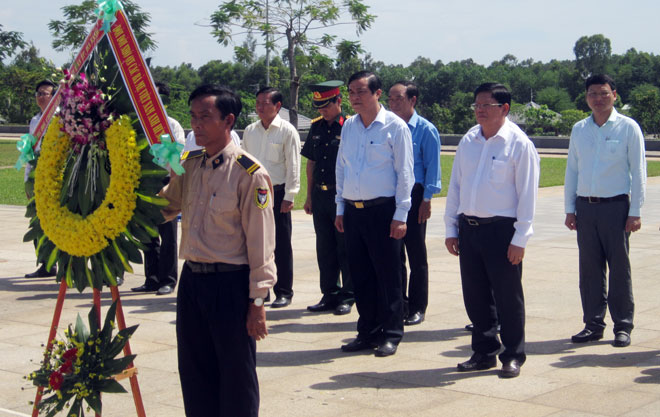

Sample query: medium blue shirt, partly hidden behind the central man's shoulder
[408,111,442,199]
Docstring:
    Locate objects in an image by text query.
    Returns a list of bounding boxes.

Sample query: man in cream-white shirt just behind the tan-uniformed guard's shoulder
[243,87,300,308]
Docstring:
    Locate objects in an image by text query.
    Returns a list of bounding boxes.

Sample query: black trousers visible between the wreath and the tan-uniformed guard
[144,220,178,289]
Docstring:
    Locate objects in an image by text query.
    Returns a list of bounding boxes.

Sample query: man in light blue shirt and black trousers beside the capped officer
[335,71,414,356]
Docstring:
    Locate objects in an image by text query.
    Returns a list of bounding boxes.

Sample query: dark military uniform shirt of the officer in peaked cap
[300,114,346,186]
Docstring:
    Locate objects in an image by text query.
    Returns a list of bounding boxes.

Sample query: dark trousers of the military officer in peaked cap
[311,187,354,304]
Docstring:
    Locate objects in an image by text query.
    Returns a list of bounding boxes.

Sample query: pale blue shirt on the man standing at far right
[564,109,646,217]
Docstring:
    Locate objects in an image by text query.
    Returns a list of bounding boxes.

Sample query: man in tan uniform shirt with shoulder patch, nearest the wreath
[161,85,276,417]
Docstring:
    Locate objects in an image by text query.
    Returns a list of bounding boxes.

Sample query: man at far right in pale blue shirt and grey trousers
[564,75,646,347]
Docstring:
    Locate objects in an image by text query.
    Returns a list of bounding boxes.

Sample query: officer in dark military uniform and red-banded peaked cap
[300,81,354,315]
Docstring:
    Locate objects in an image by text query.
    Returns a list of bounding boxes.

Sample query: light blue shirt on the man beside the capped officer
[336,106,415,223]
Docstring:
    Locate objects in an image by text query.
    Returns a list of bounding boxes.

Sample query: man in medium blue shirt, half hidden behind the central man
[388,81,442,326]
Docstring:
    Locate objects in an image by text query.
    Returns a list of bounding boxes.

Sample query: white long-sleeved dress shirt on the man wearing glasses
[445,118,540,248]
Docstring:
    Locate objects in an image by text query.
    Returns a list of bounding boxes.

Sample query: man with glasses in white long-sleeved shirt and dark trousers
[445,83,540,378]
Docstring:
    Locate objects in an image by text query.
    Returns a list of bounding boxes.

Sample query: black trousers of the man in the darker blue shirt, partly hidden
[401,183,429,316]
